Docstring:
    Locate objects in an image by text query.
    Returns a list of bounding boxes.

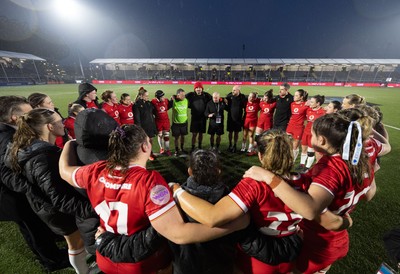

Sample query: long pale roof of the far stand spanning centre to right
[90,58,400,65]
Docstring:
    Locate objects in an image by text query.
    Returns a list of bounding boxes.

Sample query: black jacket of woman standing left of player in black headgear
[133,99,157,138]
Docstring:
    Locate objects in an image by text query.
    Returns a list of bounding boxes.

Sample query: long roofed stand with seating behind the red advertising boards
[90,58,400,83]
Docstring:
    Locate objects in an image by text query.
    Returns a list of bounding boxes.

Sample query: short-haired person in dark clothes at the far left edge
[0,96,70,271]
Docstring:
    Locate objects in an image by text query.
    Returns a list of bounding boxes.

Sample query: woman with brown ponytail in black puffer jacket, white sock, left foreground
[5,108,94,273]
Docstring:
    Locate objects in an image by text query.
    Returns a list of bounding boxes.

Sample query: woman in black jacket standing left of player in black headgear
[133,87,157,161]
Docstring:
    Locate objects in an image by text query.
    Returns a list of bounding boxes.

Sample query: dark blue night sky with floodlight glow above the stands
[0,0,400,61]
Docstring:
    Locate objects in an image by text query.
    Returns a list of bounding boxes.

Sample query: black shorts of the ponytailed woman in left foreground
[37,210,78,236]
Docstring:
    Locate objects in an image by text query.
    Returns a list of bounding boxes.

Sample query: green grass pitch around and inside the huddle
[0,84,400,274]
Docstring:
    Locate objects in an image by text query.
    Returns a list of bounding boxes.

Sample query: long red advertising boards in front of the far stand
[92,80,400,88]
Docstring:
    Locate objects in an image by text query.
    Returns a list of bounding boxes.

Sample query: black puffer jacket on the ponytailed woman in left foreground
[5,140,93,218]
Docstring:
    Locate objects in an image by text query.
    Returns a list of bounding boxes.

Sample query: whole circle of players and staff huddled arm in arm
[0,82,391,274]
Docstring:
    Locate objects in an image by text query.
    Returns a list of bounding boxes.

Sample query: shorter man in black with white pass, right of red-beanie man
[204,92,225,152]
